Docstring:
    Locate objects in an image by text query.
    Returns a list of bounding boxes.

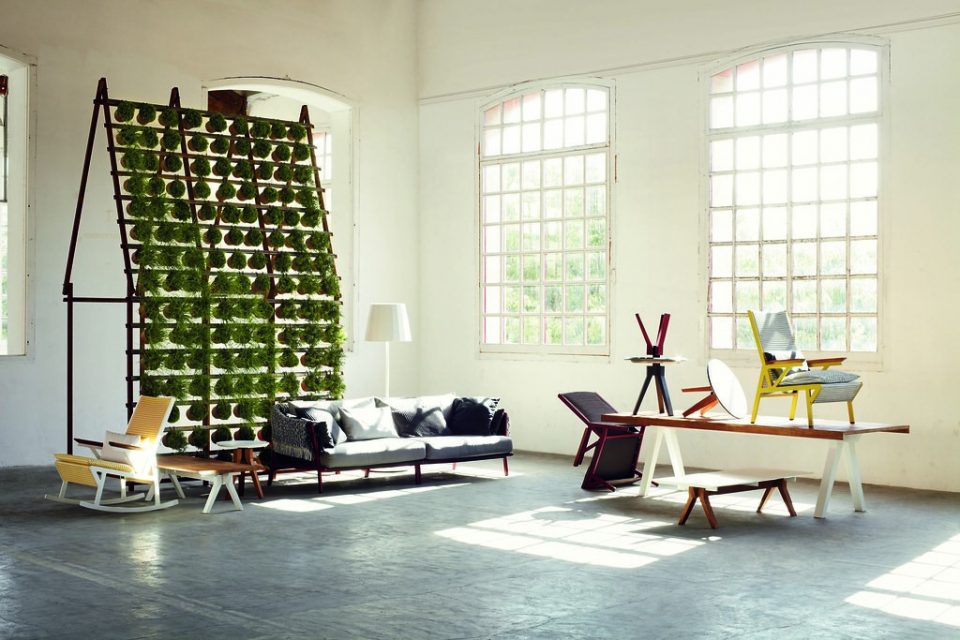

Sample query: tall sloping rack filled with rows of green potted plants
[106,100,343,450]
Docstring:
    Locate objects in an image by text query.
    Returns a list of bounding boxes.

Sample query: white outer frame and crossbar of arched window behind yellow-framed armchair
[701,36,890,368]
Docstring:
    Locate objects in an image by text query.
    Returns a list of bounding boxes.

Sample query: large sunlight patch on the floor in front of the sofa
[436,507,704,569]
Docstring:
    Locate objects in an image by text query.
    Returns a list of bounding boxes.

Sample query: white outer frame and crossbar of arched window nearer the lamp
[474,78,616,358]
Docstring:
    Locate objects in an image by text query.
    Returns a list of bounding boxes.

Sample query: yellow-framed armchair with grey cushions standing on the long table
[747,311,863,427]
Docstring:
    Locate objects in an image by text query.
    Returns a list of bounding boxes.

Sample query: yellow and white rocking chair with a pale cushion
[44,396,178,512]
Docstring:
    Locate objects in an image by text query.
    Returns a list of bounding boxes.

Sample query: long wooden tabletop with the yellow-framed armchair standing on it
[601,413,910,440]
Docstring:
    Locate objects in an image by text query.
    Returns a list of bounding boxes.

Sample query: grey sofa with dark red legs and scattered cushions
[267,394,513,492]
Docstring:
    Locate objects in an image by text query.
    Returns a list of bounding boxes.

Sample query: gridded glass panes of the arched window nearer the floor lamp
[480,83,612,354]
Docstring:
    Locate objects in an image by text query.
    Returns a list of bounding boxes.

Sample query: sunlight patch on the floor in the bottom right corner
[846,535,960,627]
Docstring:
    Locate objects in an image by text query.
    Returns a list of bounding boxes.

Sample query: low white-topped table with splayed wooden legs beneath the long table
[656,469,810,529]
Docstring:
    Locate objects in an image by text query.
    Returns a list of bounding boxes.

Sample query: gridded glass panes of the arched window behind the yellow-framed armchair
[707,43,883,352]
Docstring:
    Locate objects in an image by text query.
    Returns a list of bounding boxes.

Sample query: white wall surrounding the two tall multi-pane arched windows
[418,0,960,491]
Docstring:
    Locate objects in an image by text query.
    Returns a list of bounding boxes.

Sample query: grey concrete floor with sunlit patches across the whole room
[0,454,960,640]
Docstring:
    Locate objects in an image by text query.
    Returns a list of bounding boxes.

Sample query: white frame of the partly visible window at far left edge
[0,47,35,358]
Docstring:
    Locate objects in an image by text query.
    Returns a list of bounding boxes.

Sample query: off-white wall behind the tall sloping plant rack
[0,0,419,465]
